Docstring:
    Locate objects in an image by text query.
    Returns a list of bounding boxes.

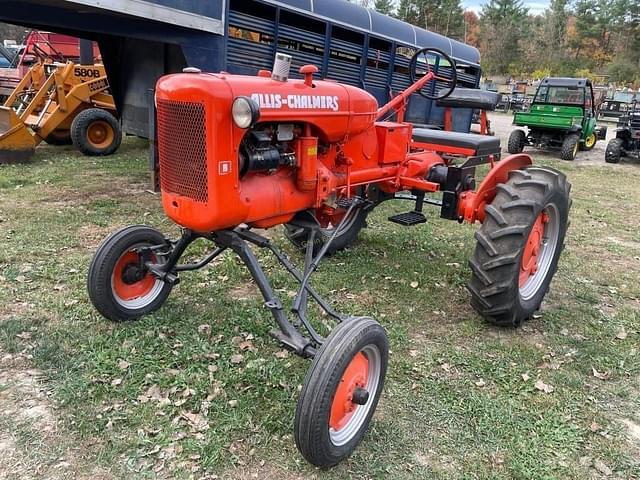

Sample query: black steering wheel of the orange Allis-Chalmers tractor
[409,47,458,100]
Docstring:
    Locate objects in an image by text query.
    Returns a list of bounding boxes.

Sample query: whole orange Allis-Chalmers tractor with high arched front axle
[88,49,570,467]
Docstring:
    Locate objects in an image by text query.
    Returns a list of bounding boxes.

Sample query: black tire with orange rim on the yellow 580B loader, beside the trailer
[71,108,122,157]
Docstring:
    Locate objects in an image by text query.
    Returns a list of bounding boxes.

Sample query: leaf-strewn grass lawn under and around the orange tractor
[0,139,640,480]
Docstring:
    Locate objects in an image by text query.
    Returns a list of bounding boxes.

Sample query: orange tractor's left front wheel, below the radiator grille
[87,225,172,322]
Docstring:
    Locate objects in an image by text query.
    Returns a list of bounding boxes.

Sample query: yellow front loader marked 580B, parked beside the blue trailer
[0,62,122,163]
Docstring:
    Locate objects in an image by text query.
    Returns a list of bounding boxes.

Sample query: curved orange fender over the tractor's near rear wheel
[458,153,533,224]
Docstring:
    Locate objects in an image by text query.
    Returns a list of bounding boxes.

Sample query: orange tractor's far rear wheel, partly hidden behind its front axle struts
[284,202,368,255]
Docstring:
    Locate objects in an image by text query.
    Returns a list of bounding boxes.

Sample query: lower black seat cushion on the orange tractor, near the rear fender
[413,128,500,157]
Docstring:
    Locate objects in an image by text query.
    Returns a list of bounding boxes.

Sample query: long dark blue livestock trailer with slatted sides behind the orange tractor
[0,0,480,137]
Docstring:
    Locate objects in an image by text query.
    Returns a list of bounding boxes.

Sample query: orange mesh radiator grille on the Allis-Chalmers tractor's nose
[158,100,209,203]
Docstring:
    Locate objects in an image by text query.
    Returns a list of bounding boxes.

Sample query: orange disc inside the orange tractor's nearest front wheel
[329,352,369,431]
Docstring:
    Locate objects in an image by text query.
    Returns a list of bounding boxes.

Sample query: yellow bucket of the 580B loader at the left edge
[0,107,36,163]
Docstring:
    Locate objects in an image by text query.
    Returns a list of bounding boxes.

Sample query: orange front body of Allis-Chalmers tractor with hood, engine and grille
[156,62,380,232]
